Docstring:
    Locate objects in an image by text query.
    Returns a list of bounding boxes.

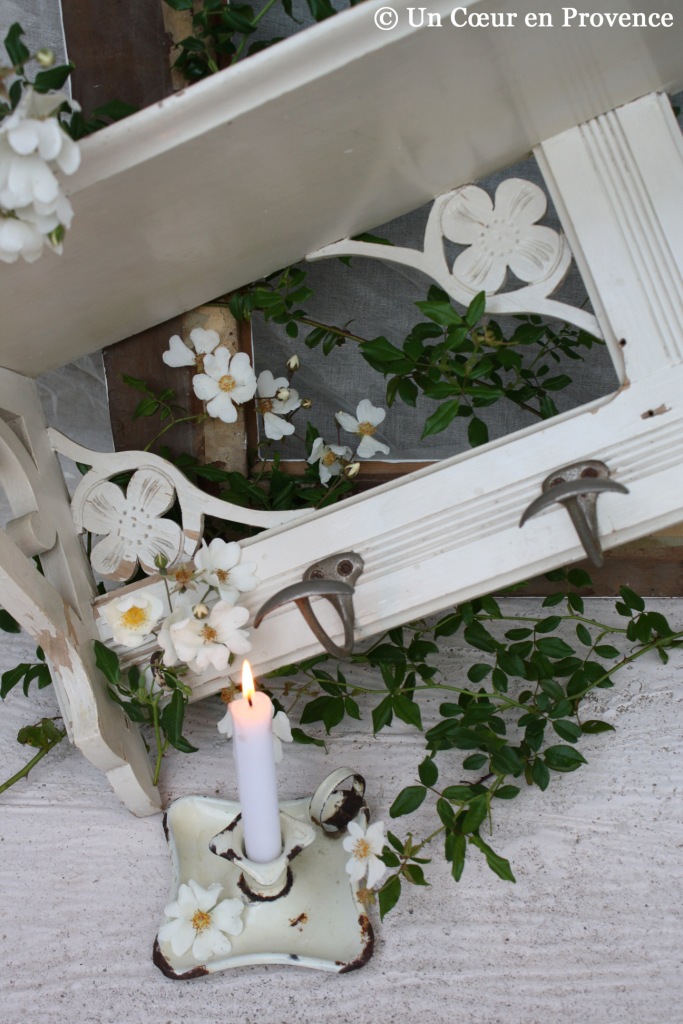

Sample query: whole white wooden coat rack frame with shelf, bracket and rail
[0,6,683,813]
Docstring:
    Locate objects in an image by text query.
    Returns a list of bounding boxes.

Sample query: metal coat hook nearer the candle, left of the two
[254,551,364,657]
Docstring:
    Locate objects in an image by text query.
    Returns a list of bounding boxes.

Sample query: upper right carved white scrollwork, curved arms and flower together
[307,178,600,336]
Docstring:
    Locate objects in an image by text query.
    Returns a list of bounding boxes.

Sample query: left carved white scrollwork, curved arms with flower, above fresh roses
[48,429,302,581]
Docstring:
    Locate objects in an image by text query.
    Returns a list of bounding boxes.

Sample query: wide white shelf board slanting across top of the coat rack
[0,0,683,376]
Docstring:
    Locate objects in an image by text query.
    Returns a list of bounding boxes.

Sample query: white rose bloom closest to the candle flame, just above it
[167,601,251,672]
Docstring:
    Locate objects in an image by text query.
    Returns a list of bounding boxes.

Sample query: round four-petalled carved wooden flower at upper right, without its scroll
[441,178,562,293]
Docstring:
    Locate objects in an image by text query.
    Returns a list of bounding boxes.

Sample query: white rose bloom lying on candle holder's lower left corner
[159,879,244,964]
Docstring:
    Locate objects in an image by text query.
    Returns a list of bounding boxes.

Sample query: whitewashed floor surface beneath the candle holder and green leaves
[0,600,683,1024]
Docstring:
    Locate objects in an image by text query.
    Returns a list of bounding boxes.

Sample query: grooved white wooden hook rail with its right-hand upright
[65,95,683,696]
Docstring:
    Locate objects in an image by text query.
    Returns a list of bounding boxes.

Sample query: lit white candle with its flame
[229,662,283,864]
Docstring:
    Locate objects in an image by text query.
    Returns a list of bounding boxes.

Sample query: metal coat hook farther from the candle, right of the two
[519,459,629,568]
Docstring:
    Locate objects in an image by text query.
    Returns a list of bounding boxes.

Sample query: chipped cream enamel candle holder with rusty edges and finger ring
[153,768,374,980]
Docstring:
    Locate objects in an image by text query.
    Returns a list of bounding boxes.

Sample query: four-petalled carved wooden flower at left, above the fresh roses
[83,469,182,580]
